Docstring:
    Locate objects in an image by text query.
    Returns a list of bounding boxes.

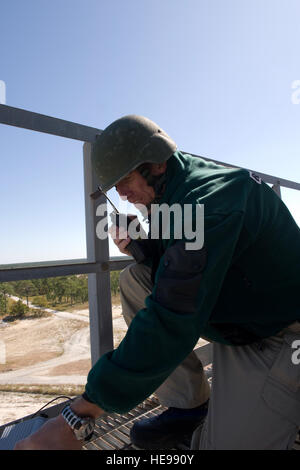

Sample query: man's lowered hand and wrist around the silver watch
[14,397,104,450]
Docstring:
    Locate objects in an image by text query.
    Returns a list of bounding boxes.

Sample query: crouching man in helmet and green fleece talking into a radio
[17,116,300,449]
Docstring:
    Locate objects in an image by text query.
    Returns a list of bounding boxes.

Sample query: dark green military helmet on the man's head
[92,115,177,191]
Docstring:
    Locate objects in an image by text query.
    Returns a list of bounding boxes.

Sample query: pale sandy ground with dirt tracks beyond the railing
[0,306,127,426]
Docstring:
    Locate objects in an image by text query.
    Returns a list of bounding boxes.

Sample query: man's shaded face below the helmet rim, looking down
[116,170,155,206]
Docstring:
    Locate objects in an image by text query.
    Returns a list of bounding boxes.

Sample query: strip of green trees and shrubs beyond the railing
[0,271,120,319]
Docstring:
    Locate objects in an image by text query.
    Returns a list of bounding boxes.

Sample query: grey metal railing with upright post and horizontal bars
[0,105,300,364]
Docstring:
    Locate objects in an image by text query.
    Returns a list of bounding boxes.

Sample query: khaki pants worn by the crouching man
[120,264,300,449]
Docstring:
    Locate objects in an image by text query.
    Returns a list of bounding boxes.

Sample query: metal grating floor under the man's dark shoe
[83,398,300,450]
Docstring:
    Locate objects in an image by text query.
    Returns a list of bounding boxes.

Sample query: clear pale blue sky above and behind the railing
[0,0,300,264]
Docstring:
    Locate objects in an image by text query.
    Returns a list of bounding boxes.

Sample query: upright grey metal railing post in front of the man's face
[83,142,113,365]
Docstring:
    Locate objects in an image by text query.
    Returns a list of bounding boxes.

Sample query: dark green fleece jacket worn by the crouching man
[85,151,300,413]
